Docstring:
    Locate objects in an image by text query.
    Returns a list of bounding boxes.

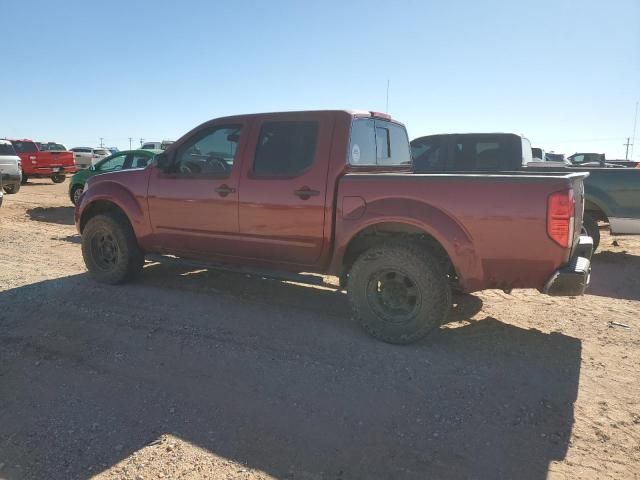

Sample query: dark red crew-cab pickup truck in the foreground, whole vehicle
[75,111,592,343]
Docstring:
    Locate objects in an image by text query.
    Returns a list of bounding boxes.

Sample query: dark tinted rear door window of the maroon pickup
[253,121,318,177]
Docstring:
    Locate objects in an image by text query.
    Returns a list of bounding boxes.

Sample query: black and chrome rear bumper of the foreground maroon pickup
[542,235,593,297]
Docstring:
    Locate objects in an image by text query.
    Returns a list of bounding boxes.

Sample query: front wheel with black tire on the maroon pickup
[82,213,144,285]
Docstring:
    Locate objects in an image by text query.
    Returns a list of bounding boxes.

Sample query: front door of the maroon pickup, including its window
[147,122,248,256]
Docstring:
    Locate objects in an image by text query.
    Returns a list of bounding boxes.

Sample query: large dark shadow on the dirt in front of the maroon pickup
[0,265,581,480]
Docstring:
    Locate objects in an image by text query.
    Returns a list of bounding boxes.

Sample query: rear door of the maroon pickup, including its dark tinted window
[239,113,336,265]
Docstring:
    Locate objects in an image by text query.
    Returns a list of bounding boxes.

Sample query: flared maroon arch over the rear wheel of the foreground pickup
[340,222,457,286]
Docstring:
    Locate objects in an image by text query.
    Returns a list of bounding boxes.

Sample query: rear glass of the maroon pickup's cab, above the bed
[348,118,411,166]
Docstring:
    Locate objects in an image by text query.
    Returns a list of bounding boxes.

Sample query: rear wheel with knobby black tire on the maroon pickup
[347,242,451,345]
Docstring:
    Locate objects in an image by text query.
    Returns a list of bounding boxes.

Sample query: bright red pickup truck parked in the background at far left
[10,140,77,183]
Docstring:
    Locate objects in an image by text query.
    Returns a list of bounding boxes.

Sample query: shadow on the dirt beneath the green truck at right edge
[587,251,640,300]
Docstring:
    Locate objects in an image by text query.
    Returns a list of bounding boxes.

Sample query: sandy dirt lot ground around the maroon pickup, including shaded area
[0,180,640,479]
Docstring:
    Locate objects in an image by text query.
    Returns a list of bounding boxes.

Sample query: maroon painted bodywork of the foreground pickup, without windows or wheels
[76,111,582,291]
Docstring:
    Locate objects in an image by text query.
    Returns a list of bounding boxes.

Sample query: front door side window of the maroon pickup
[169,125,242,178]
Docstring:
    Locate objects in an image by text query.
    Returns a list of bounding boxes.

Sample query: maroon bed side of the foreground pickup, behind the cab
[336,172,588,291]
